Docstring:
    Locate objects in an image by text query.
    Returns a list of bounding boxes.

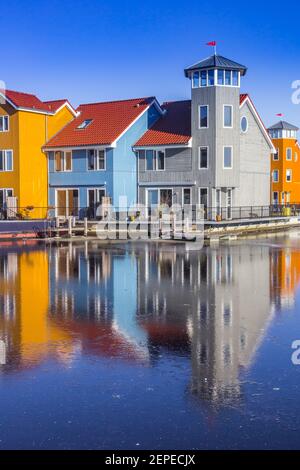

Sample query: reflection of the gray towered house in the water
[138,246,276,402]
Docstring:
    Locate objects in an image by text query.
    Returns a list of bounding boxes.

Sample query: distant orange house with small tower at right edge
[268,121,300,205]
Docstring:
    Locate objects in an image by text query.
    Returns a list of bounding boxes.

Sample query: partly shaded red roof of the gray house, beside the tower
[135,100,191,147]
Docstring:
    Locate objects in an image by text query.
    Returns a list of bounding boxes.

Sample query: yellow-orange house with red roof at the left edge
[0,90,77,218]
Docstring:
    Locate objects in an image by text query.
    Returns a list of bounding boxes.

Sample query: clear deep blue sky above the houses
[0,0,300,127]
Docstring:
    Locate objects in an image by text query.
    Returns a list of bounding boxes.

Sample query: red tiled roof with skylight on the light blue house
[45,97,155,148]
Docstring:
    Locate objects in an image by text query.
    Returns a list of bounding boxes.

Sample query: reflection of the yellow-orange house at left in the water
[0,244,72,367]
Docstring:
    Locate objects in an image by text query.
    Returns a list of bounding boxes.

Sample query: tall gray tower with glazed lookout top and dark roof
[185,54,247,218]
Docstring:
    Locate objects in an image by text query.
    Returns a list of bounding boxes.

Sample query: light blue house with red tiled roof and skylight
[44,97,163,218]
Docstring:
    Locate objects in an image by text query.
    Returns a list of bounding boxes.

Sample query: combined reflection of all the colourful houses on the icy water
[0,235,300,404]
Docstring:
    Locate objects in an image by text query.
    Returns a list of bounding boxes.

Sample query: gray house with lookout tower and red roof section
[134,55,275,219]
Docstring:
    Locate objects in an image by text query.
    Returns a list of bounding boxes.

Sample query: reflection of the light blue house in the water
[51,243,147,361]
